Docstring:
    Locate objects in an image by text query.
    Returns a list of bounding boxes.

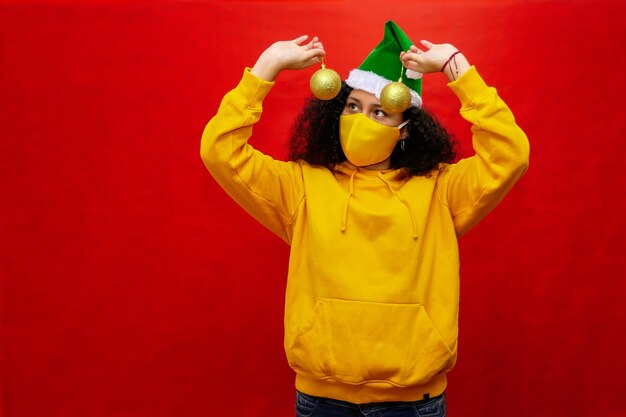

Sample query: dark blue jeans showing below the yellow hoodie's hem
[296,391,446,417]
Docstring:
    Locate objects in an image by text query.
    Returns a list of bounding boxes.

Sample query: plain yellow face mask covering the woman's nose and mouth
[339,113,409,167]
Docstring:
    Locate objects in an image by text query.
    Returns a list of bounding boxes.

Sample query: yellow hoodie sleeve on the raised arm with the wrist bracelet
[438,67,529,236]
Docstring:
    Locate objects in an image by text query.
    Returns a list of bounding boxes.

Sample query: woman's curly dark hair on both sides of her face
[289,83,458,177]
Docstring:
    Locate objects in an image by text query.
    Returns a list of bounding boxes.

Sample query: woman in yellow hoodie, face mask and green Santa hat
[201,22,528,416]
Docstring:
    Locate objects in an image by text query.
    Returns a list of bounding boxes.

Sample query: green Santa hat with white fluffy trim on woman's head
[346,20,422,108]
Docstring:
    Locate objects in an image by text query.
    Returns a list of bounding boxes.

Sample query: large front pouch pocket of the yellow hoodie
[289,298,453,386]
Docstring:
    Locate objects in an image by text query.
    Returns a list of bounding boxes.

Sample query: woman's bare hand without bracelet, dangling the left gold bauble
[250,35,326,81]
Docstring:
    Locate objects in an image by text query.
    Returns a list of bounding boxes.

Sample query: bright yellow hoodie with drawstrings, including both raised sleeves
[201,67,529,403]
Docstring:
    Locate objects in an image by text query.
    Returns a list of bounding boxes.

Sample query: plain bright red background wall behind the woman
[0,0,626,417]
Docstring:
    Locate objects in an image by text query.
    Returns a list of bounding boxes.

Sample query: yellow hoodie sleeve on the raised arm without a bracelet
[200,68,303,243]
